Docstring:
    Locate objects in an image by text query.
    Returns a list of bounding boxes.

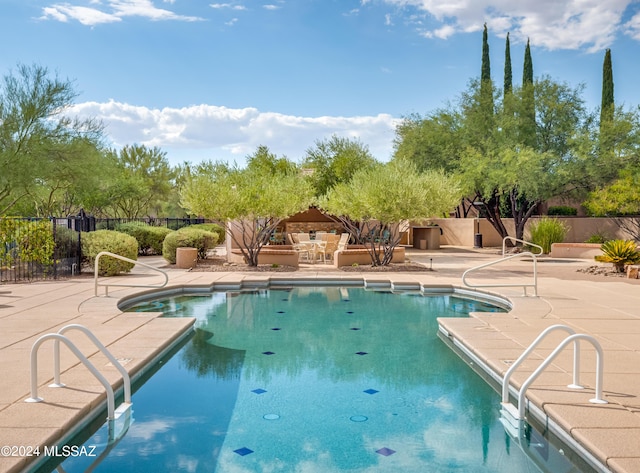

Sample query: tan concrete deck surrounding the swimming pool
[0,247,640,473]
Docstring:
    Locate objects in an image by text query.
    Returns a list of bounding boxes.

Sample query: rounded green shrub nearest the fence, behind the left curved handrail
[82,230,138,276]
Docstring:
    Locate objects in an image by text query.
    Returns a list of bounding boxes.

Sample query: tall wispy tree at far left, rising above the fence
[0,65,102,215]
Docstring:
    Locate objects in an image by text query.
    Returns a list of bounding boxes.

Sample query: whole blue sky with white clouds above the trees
[0,0,640,166]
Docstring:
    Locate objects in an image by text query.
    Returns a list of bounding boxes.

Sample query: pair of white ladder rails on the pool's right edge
[500,324,608,438]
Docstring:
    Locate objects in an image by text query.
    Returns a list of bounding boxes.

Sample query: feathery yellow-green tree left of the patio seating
[180,147,313,266]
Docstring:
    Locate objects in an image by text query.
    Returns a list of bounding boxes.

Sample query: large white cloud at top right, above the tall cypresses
[384,0,640,51]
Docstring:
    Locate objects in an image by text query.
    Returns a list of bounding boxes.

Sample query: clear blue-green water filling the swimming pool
[53,287,580,473]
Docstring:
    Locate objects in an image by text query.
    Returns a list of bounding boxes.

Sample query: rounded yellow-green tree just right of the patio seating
[322,160,462,266]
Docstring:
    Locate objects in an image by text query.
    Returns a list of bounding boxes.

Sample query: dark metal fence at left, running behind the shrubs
[0,212,206,284]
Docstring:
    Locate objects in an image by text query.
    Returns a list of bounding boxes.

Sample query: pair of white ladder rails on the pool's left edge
[25,324,132,432]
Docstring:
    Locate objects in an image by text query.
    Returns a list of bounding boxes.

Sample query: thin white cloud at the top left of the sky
[41,0,201,26]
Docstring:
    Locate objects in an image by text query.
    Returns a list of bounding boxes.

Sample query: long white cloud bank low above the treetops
[71,100,399,164]
